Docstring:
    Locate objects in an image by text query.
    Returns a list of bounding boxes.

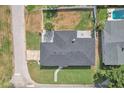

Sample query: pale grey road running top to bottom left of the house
[11,5,33,87]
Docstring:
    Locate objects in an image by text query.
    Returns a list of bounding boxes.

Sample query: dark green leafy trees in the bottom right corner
[94,69,124,88]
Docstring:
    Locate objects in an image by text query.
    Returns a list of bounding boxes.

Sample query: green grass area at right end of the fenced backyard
[75,11,93,30]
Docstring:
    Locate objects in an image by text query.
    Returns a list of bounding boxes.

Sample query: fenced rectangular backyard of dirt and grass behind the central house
[44,10,93,31]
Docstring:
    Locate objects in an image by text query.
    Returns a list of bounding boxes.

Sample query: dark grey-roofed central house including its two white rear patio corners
[40,31,95,67]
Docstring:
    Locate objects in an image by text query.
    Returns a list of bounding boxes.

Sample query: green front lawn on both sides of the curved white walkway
[28,62,94,84]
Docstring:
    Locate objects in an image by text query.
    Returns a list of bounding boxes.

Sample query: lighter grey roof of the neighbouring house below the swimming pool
[102,20,124,65]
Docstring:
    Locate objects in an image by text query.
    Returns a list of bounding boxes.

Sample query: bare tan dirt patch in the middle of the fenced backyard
[53,11,81,30]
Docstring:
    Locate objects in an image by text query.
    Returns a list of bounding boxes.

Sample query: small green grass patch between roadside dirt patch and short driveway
[26,31,40,50]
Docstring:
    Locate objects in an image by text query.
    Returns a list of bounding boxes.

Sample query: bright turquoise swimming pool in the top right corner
[112,9,124,19]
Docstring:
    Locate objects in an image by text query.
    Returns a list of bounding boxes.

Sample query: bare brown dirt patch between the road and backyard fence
[26,11,42,32]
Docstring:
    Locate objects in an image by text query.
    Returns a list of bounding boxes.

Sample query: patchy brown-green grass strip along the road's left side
[0,6,13,87]
